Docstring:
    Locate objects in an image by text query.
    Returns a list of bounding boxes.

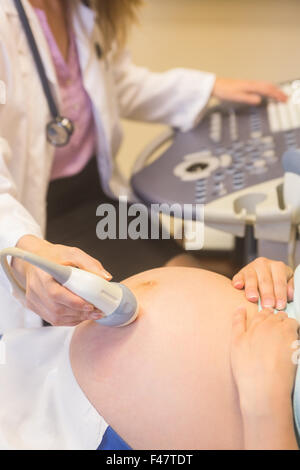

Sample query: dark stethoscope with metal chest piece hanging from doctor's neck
[14,0,74,147]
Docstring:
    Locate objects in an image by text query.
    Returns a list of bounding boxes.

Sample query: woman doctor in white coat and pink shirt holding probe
[0,0,286,333]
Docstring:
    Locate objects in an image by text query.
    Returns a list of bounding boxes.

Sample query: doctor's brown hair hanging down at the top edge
[90,0,143,53]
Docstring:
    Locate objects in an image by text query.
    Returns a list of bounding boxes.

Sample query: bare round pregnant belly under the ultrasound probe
[70,268,257,449]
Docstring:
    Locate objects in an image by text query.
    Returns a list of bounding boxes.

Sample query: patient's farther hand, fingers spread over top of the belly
[232,258,294,310]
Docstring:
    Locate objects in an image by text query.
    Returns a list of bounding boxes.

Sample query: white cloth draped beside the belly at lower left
[0,327,107,450]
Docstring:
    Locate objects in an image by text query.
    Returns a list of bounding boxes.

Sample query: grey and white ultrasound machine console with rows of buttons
[131,80,300,266]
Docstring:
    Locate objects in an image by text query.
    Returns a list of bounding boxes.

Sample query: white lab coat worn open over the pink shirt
[0,0,215,333]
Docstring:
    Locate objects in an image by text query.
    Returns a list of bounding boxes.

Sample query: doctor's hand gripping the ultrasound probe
[12,235,112,326]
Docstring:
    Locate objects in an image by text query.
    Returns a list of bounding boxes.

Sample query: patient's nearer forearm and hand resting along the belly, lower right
[231,308,298,450]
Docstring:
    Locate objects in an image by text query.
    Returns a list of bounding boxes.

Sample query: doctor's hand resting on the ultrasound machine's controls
[212,78,288,105]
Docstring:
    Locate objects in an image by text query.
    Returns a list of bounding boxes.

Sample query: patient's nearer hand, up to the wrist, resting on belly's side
[231,308,299,416]
